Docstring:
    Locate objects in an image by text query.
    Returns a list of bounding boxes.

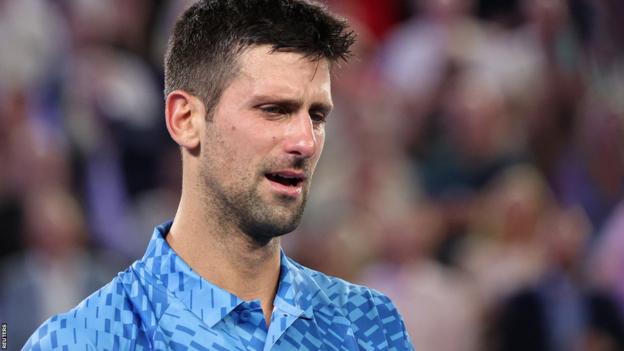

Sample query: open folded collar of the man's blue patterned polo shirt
[137,221,326,328]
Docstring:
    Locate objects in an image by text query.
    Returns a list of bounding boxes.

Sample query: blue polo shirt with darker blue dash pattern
[23,222,413,351]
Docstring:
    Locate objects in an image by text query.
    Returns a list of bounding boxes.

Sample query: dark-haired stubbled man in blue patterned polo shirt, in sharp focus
[24,0,412,350]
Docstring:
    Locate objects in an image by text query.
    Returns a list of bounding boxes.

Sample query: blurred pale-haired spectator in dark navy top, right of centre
[411,67,526,264]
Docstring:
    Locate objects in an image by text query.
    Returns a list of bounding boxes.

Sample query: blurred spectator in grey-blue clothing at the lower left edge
[0,187,114,345]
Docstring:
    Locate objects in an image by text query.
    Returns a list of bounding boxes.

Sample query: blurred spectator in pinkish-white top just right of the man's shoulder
[358,204,482,351]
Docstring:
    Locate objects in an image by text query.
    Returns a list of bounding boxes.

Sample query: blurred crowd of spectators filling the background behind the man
[0,0,624,351]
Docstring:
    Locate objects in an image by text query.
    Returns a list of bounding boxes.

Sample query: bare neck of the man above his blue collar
[166,190,280,326]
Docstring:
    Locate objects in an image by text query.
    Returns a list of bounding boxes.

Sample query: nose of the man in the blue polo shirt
[284,112,318,158]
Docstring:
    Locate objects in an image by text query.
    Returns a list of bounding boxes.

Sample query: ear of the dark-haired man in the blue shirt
[165,90,206,150]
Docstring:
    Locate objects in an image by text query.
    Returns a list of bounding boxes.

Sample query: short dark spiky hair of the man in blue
[165,0,355,115]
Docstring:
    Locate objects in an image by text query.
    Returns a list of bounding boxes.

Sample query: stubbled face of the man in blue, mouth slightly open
[199,46,332,244]
